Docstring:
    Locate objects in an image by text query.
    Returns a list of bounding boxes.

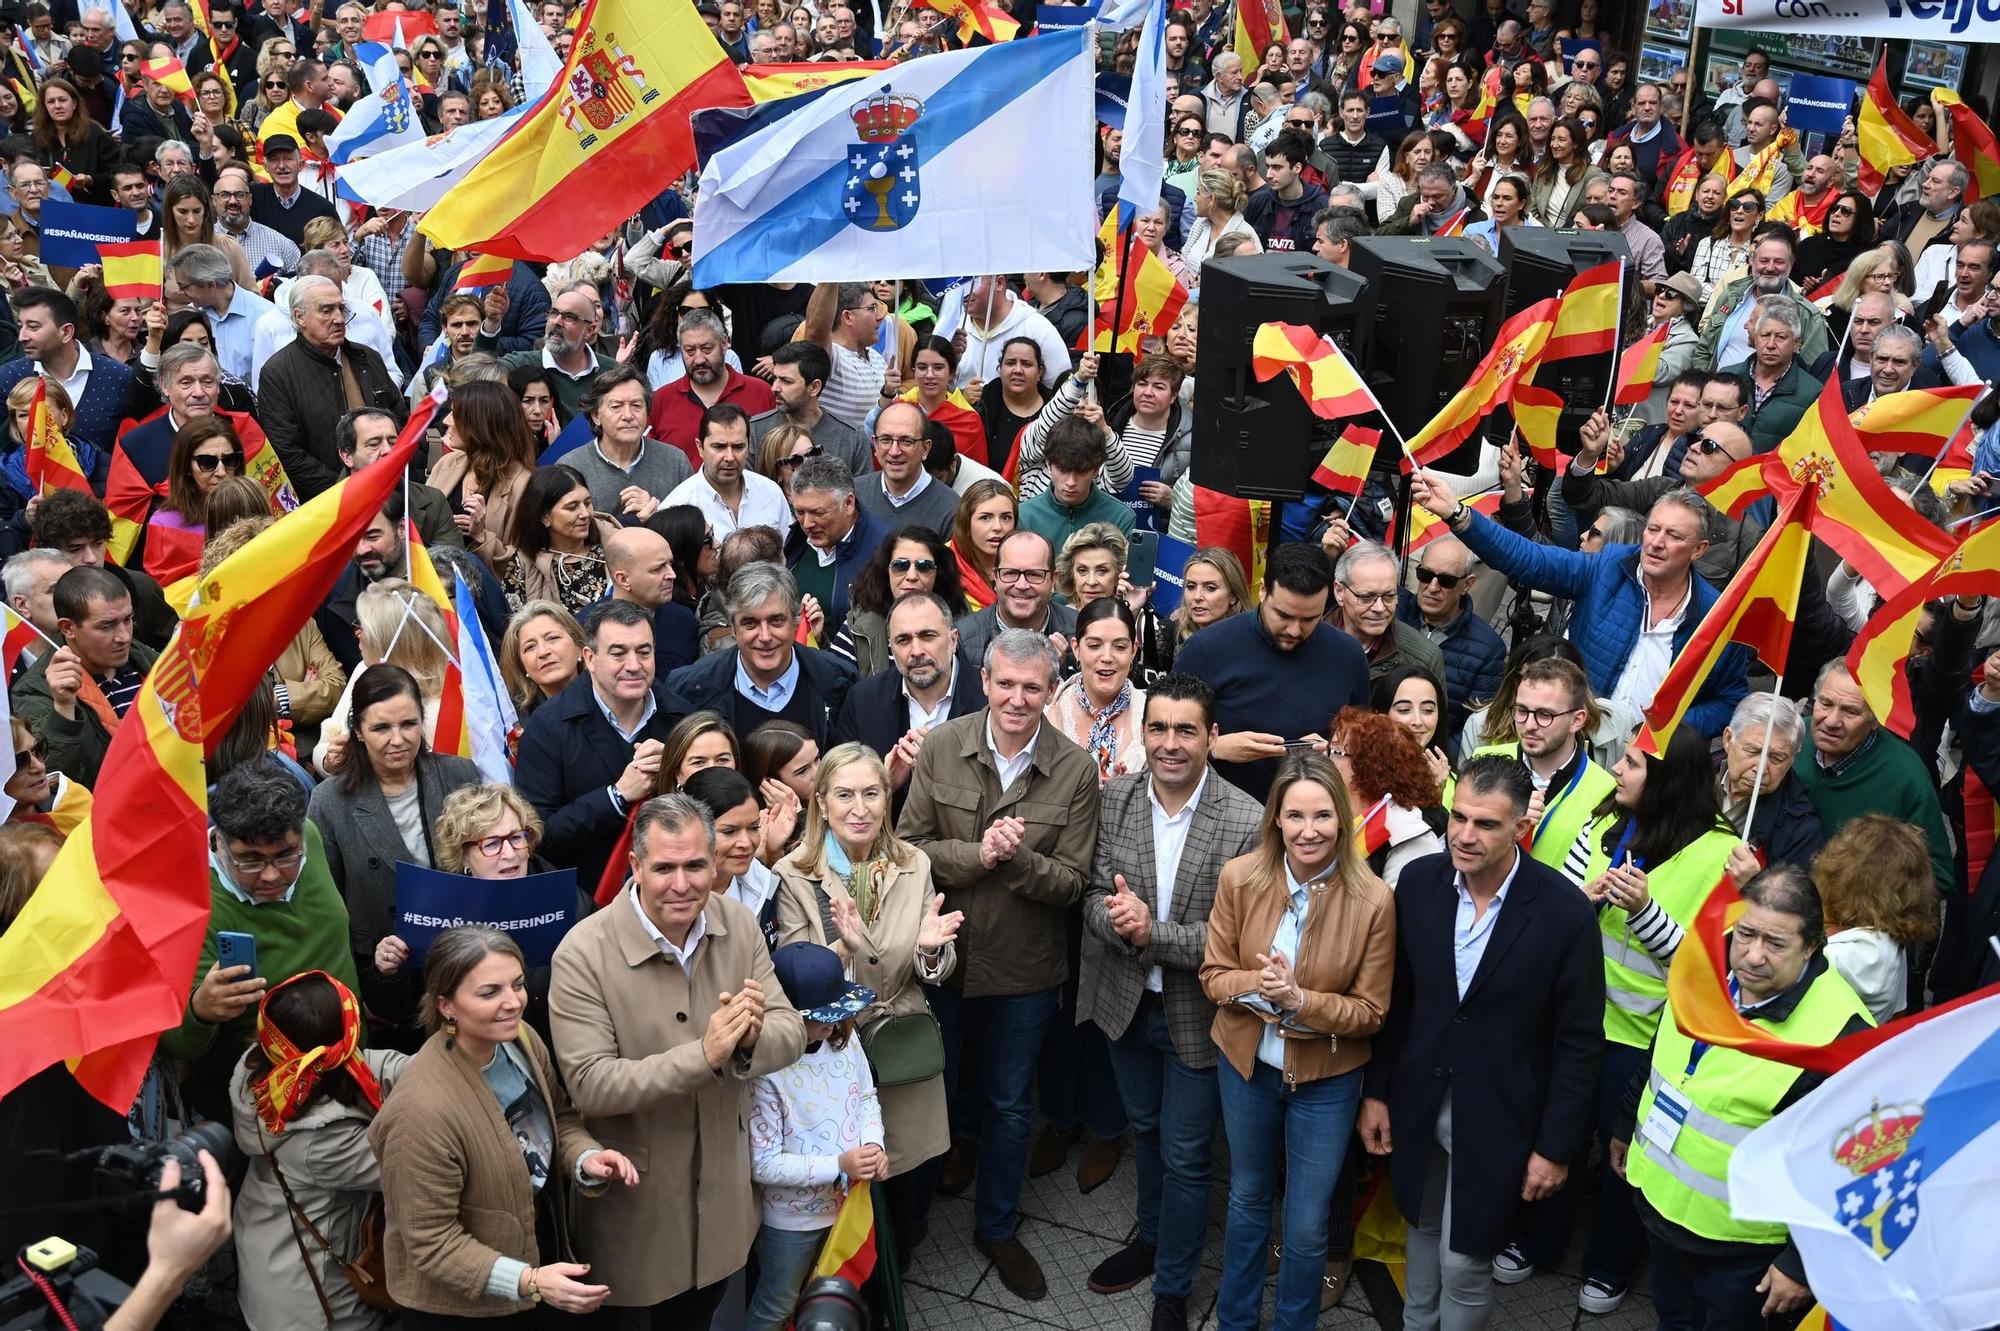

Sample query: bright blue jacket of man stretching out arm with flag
[1460,514,1750,739]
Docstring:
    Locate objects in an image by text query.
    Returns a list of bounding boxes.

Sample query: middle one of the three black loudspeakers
[1348,236,1506,474]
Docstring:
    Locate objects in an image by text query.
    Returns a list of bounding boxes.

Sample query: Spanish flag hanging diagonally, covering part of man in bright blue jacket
[1634,490,1814,757]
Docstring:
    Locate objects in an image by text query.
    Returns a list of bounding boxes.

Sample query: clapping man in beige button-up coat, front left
[548,795,806,1331]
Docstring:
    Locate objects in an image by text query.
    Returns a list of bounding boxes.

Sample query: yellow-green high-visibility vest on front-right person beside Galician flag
[1626,959,1868,1245]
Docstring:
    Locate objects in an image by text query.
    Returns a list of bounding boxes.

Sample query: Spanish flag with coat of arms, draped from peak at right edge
[1700,376,1954,596]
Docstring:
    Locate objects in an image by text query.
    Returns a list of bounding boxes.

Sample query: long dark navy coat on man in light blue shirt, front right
[1364,855,1604,1255]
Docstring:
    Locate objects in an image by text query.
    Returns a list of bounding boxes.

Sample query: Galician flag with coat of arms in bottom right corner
[1730,995,2000,1331]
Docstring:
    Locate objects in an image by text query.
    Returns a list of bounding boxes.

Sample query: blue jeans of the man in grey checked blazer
[1108,993,1222,1299]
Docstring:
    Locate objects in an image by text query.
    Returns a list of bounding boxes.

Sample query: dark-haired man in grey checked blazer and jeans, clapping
[1076,673,1264,1331]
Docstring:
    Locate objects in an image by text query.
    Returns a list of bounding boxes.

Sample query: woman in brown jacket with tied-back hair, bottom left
[368,925,632,1331]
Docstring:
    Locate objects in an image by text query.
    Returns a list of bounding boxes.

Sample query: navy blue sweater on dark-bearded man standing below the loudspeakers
[1174,610,1368,799]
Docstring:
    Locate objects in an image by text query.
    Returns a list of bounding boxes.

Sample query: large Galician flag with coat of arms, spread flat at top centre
[694,30,1098,288]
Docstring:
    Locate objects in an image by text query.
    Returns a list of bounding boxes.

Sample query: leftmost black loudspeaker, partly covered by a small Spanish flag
[1192,254,1376,500]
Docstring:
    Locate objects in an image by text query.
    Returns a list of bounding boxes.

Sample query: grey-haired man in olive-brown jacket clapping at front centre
[898,630,1098,1299]
